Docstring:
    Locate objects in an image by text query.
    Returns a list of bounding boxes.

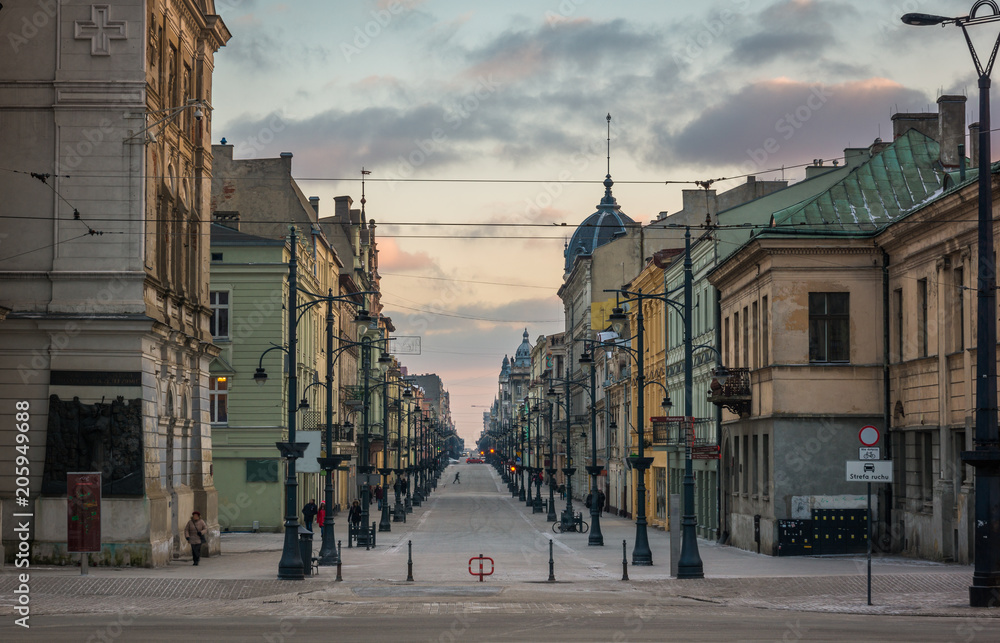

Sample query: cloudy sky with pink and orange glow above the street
[213,0,984,444]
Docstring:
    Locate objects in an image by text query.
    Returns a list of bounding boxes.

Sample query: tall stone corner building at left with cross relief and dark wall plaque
[0,0,230,566]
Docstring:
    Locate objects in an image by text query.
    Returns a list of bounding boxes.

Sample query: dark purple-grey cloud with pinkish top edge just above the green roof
[646,78,929,169]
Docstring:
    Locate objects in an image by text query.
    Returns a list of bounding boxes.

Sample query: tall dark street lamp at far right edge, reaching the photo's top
[902,0,1000,607]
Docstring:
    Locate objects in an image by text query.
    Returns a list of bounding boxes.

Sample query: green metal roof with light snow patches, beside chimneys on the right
[760,129,945,236]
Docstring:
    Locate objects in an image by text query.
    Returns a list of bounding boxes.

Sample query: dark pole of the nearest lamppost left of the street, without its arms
[277,226,305,580]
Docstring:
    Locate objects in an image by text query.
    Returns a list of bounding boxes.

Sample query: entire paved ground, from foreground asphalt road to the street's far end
[0,464,1000,643]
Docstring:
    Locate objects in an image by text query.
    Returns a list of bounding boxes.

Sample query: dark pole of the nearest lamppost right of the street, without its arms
[676,228,705,578]
